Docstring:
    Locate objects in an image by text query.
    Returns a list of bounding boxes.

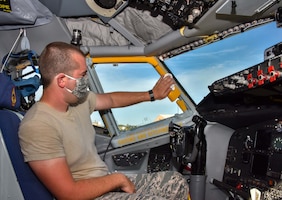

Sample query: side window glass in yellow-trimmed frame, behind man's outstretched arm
[91,63,182,131]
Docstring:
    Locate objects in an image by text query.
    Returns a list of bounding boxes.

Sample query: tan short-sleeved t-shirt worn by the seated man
[19,92,108,180]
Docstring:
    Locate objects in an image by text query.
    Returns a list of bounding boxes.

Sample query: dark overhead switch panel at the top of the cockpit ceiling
[86,0,218,30]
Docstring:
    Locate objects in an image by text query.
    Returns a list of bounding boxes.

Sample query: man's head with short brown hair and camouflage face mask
[39,42,88,105]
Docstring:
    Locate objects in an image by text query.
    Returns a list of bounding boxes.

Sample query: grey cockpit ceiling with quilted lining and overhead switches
[41,0,282,59]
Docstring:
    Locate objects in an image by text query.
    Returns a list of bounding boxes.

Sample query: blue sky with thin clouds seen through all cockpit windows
[92,22,282,125]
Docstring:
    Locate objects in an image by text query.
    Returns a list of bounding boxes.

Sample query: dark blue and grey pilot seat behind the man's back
[0,109,54,200]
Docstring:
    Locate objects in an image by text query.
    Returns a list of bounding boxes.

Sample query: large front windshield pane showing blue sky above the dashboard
[165,22,282,103]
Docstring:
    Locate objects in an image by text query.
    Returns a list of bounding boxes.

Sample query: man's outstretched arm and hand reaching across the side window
[95,76,175,110]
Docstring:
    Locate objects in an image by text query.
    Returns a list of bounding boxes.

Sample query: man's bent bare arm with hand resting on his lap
[29,157,135,200]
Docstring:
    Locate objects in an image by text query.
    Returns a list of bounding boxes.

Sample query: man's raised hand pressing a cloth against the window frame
[152,75,175,100]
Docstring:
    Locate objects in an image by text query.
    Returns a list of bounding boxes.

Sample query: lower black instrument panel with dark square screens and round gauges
[223,117,282,191]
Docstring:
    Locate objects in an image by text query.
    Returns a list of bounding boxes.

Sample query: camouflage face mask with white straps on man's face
[65,74,89,101]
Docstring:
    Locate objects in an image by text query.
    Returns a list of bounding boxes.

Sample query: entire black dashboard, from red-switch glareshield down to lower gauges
[202,43,282,196]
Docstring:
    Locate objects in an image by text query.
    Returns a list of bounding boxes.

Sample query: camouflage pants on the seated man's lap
[96,171,189,200]
